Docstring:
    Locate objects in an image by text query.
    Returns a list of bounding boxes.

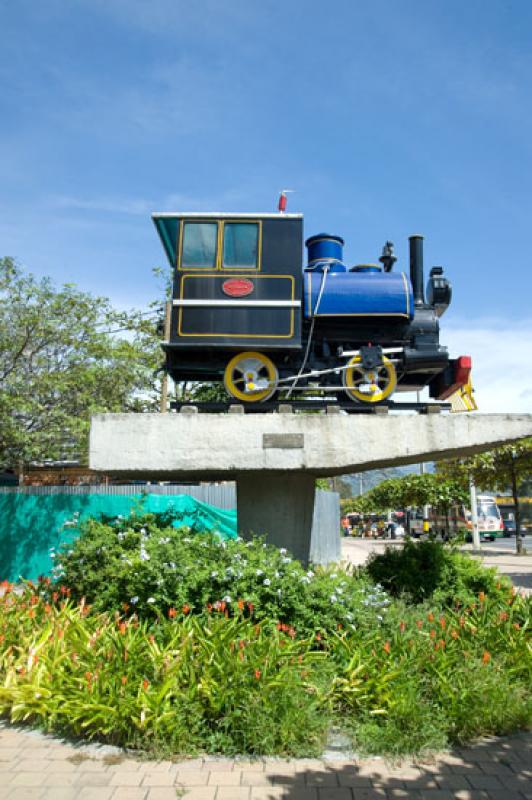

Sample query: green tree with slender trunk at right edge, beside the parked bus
[439,438,532,553]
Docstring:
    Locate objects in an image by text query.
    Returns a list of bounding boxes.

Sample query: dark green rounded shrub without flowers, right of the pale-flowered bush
[367,541,511,605]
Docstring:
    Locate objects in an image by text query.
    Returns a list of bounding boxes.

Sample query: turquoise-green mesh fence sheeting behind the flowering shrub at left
[0,493,237,581]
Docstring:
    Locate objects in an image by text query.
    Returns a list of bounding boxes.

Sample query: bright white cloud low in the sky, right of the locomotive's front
[440,318,532,413]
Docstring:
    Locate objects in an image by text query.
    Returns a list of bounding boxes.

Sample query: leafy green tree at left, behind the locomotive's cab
[0,258,161,468]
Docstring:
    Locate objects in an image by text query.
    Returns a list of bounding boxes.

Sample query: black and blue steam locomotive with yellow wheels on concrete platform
[152,213,471,405]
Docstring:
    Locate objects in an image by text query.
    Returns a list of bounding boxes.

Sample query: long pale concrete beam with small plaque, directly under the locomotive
[90,414,532,480]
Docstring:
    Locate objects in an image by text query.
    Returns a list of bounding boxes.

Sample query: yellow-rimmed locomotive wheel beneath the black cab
[224,351,279,403]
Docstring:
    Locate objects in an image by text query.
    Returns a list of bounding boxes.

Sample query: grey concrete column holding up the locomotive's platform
[236,472,315,564]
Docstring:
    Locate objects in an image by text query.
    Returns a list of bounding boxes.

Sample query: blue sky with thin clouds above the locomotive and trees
[0,0,532,410]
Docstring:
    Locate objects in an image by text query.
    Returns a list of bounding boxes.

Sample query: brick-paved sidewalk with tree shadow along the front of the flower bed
[0,725,532,800]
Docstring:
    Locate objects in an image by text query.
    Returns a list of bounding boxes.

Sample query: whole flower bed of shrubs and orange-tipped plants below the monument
[0,517,532,755]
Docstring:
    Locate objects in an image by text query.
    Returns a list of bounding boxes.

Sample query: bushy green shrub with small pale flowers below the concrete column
[50,514,389,637]
